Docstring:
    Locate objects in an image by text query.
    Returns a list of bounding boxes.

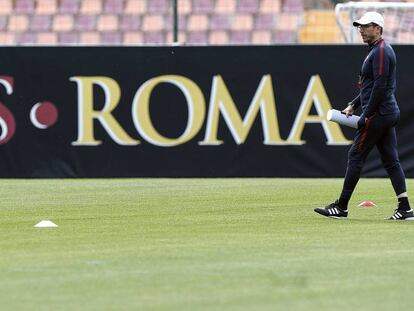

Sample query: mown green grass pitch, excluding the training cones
[0,179,414,311]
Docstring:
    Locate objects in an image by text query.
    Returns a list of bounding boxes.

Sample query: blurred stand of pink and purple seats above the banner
[0,0,414,45]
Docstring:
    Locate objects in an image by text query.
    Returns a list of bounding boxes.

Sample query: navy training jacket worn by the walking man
[351,39,400,118]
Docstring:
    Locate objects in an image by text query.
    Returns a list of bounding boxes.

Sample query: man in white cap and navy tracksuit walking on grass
[315,12,414,220]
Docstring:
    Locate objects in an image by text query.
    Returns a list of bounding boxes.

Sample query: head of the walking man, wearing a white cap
[353,12,384,44]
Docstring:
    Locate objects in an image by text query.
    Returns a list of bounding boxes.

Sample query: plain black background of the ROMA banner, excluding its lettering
[0,45,414,177]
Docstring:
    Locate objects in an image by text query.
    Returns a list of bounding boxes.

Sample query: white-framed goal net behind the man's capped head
[335,2,414,44]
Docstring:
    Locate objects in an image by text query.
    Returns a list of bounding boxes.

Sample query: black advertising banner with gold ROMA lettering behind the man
[0,45,414,178]
